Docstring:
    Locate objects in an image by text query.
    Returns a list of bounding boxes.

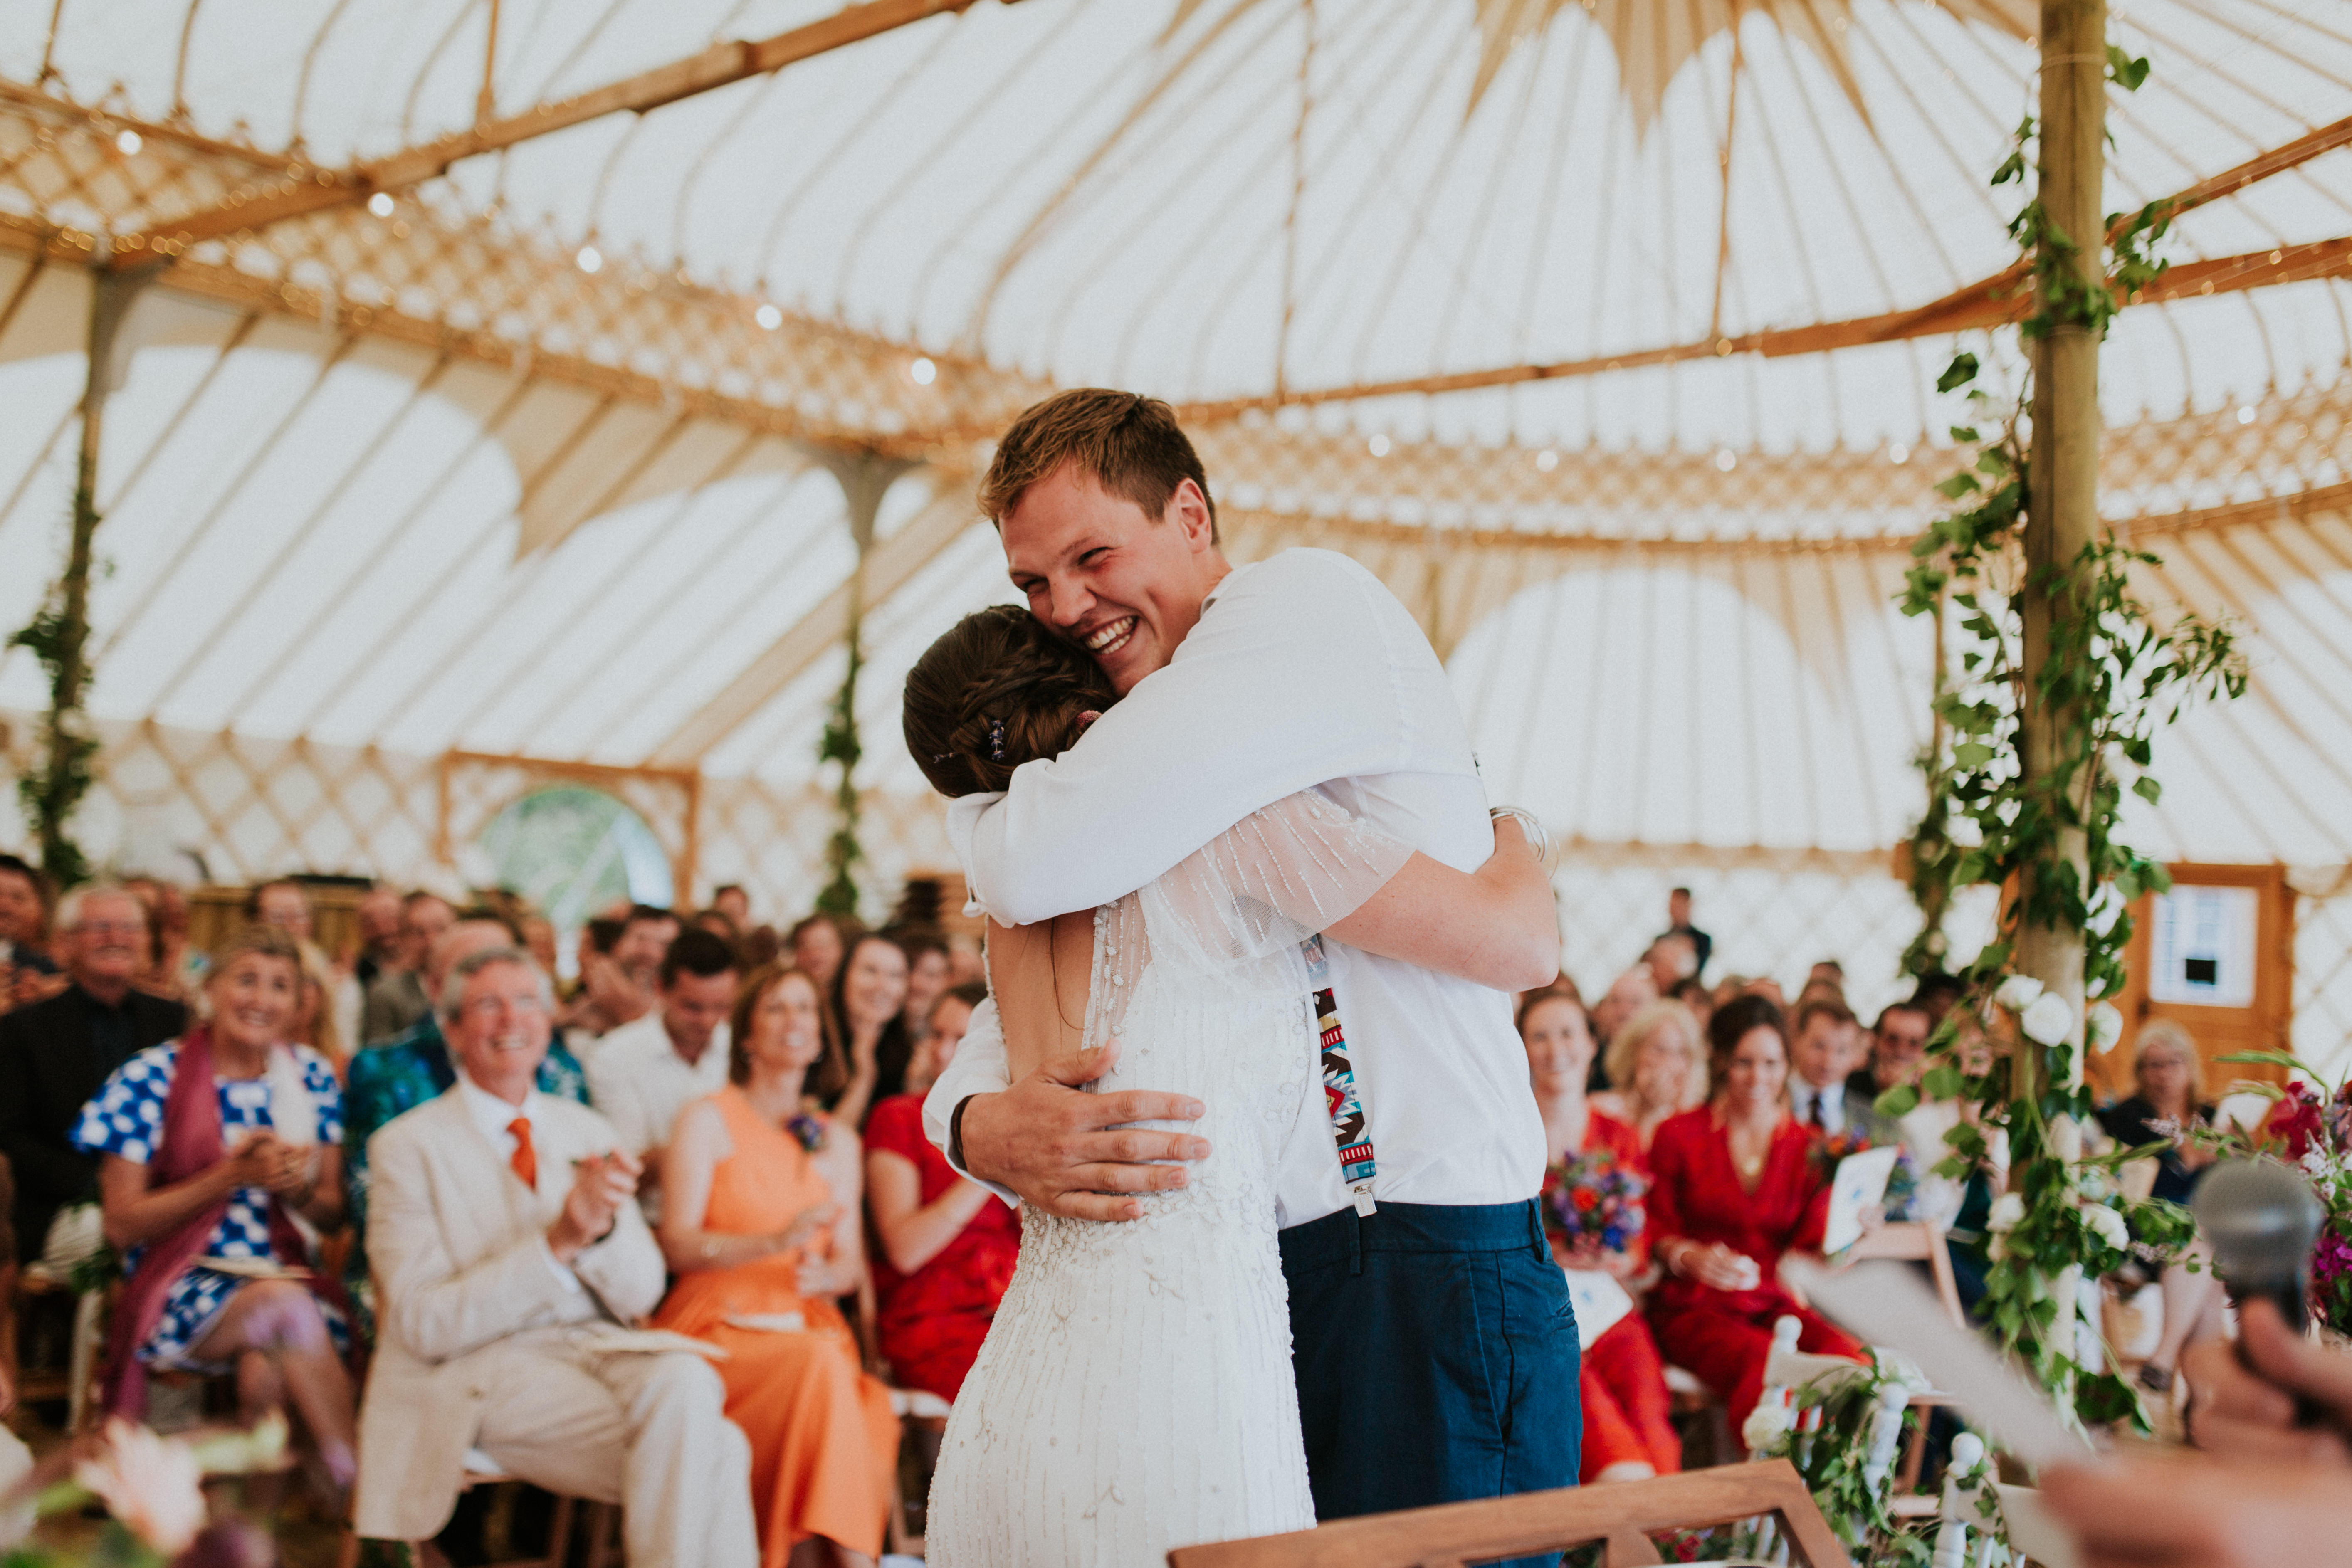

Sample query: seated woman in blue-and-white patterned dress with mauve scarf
[73,926,355,1486]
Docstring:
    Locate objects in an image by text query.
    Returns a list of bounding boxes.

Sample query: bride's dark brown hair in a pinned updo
[906,604,1119,797]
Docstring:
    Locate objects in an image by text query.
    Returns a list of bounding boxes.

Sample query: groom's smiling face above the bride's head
[997,463,1225,696]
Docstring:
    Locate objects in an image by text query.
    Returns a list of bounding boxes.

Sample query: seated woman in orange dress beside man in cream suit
[654,964,899,1568]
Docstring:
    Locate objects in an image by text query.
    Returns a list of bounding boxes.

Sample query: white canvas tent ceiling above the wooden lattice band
[18,0,2352,447]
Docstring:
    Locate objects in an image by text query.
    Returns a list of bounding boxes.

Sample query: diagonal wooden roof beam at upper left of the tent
[113,0,1009,268]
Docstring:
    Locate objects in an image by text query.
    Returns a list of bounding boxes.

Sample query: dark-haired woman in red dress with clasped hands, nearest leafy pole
[1649,997,1863,1432]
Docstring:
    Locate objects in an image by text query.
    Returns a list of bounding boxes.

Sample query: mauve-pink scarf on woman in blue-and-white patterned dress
[106,1025,348,1420]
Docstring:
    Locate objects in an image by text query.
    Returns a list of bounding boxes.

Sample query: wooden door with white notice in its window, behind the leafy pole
[2089,865,2295,1096]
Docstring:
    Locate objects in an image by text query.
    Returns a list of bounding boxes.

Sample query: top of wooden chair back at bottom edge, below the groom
[1169,1460,1851,1568]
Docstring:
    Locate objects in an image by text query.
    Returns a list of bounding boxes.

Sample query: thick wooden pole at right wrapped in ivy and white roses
[1882,15,2246,1422]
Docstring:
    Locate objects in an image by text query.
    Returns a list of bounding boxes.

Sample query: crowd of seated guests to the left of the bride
[0,858,1018,1568]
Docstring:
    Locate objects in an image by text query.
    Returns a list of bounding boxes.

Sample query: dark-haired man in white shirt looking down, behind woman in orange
[588,926,743,1222]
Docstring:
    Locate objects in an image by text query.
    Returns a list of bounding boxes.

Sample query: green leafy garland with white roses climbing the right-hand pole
[1879,47,2246,1422]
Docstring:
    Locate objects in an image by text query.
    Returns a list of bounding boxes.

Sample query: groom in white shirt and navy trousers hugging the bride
[924,388,1581,1519]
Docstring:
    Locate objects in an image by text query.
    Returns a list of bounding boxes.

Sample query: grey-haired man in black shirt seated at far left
[0,884,188,1262]
